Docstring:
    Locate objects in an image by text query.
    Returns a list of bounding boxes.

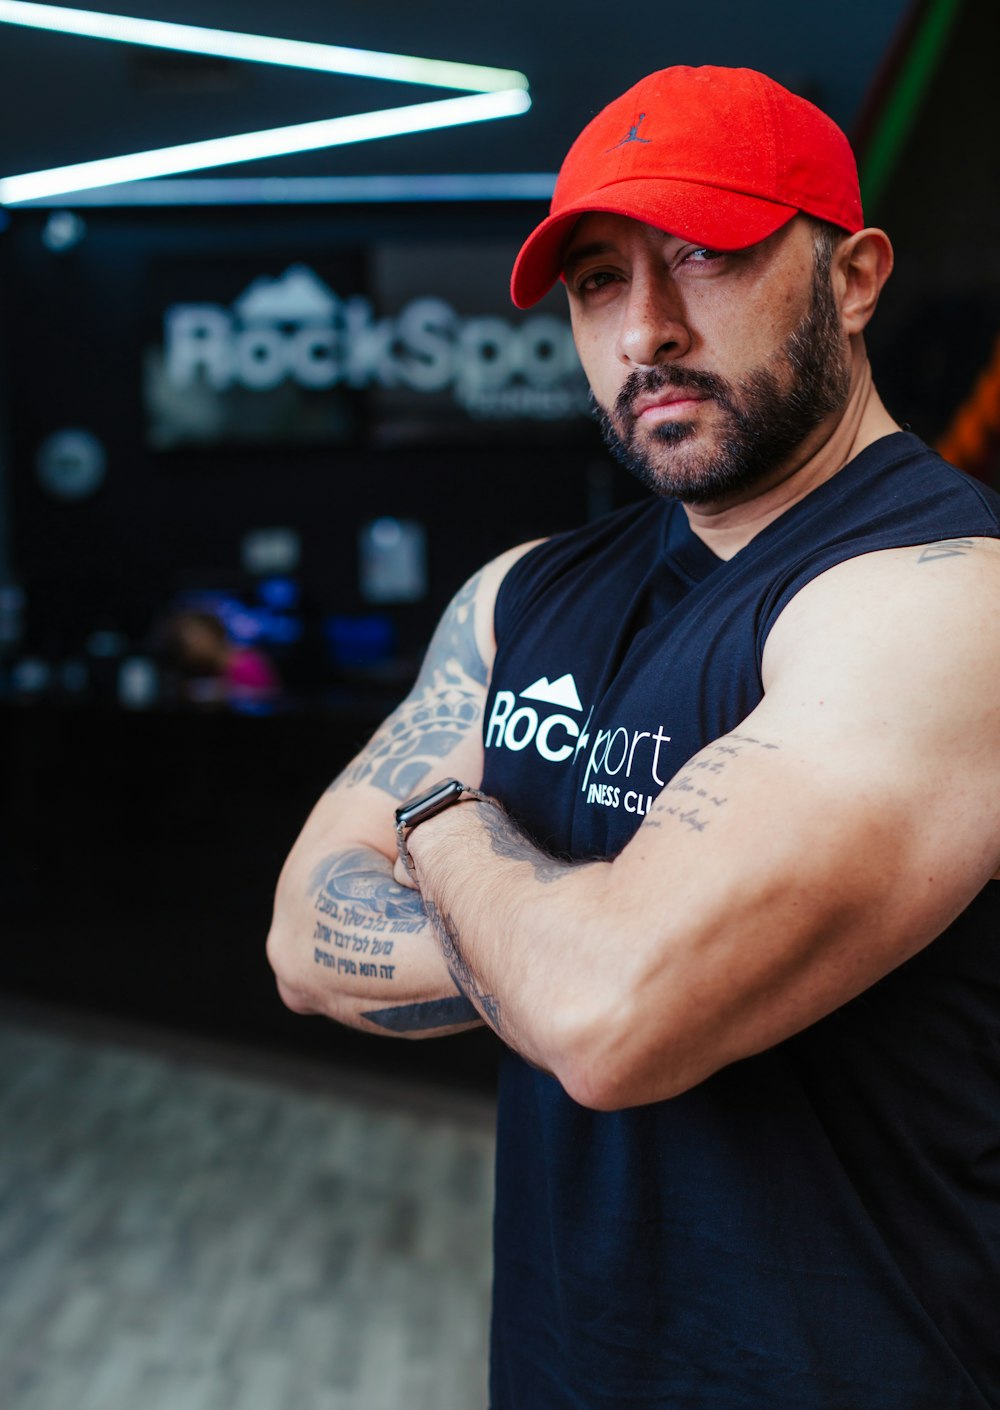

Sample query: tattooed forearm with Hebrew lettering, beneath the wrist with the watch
[268,842,478,1036]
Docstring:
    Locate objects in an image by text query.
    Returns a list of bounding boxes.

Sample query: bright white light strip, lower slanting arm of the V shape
[0,89,532,206]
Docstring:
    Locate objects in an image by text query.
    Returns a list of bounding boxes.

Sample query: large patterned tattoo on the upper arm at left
[330,574,487,801]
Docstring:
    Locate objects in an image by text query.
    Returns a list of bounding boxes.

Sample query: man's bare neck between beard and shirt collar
[684,353,900,558]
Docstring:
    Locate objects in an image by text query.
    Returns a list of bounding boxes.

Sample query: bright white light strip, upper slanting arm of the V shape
[0,0,528,93]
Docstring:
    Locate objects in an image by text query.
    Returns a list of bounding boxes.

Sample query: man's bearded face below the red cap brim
[566,213,850,505]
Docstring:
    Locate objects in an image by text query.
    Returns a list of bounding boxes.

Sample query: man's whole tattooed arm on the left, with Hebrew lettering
[268,546,529,1038]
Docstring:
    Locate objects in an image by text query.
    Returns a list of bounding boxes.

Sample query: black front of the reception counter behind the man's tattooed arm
[0,705,507,1089]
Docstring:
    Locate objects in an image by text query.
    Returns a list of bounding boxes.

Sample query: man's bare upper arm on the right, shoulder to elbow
[592,538,1000,1090]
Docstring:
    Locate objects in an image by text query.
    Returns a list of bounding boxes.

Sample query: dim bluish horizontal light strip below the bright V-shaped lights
[13,172,556,205]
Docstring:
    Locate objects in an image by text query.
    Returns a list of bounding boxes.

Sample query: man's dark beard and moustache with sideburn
[591,261,850,505]
